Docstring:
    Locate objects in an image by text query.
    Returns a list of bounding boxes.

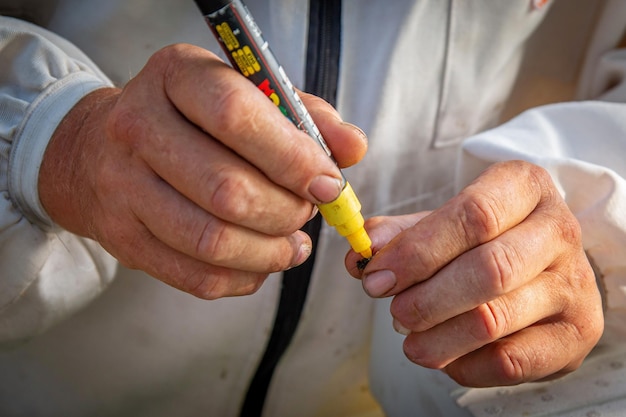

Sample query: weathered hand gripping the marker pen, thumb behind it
[39,45,366,299]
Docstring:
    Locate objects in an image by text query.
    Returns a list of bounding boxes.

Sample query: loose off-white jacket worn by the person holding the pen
[0,0,626,417]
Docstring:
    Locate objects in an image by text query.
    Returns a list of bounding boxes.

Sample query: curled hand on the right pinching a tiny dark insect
[346,161,603,387]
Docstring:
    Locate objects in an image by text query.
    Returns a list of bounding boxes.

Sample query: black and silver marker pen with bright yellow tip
[195,0,372,258]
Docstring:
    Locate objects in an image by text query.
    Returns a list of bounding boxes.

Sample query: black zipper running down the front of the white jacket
[239,0,341,417]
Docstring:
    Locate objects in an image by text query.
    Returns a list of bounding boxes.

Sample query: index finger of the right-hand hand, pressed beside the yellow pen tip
[363,161,549,297]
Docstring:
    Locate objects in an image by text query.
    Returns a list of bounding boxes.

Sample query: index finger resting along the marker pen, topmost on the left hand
[158,45,341,203]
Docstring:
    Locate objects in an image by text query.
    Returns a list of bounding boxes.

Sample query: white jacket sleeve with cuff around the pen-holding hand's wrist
[0,16,117,345]
